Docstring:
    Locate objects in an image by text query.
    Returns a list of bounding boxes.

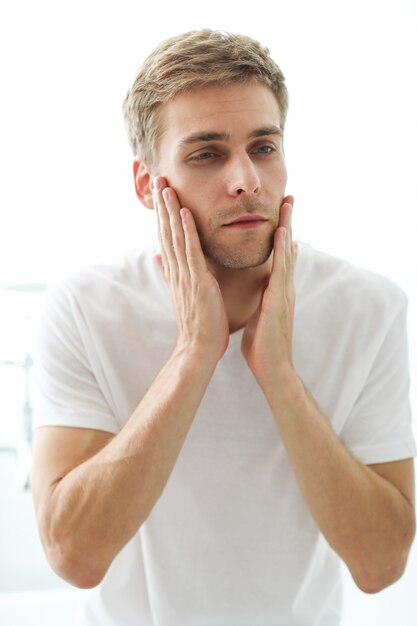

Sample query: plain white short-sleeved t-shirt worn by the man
[36,242,416,626]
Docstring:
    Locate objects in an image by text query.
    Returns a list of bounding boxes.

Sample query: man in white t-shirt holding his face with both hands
[33,30,415,626]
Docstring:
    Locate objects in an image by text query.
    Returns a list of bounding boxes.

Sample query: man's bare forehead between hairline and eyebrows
[159,82,280,147]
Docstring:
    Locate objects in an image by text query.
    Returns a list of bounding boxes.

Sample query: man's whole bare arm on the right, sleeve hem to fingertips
[242,205,415,592]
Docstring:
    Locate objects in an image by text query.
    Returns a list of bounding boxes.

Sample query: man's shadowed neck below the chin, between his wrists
[208,255,272,333]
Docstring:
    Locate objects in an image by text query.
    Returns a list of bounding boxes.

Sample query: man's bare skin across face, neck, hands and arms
[32,85,415,592]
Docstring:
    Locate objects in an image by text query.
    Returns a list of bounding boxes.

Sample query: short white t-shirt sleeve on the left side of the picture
[34,283,120,433]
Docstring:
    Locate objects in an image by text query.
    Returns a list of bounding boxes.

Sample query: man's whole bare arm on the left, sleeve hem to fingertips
[32,178,229,587]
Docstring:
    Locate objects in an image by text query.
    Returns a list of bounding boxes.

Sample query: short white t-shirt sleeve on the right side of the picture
[341,292,416,464]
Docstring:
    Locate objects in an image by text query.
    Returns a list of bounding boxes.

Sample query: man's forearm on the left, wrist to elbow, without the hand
[40,346,215,586]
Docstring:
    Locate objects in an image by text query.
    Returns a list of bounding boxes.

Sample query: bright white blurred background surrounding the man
[0,0,417,626]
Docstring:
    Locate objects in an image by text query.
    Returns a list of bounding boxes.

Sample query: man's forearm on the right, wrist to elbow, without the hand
[267,369,414,591]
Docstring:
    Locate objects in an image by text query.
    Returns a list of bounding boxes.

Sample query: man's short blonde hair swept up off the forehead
[123,28,288,167]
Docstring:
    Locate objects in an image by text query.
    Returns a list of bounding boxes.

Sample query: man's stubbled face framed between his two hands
[157,83,287,269]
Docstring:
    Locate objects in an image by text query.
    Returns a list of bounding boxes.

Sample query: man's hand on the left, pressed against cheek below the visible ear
[153,177,229,362]
